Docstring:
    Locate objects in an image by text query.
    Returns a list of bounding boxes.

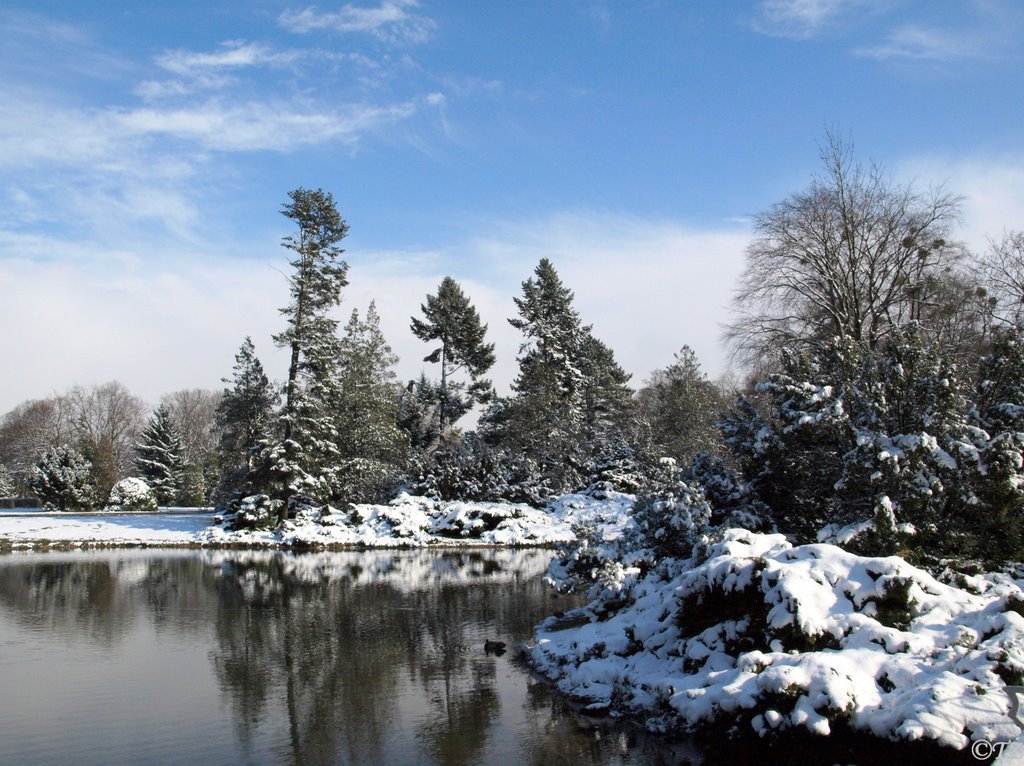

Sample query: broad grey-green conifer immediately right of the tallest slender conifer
[332,302,409,503]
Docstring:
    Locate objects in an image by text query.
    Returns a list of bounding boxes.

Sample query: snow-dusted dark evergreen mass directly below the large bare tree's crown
[725,332,968,541]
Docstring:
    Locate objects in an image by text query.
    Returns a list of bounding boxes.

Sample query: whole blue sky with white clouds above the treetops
[0,0,1024,414]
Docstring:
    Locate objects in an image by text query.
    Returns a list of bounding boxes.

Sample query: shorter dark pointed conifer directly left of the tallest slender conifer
[216,337,280,492]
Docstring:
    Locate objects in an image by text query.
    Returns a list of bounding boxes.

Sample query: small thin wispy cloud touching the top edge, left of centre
[279,0,436,43]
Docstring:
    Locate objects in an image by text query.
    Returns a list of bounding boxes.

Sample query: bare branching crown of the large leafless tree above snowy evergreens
[727,133,961,360]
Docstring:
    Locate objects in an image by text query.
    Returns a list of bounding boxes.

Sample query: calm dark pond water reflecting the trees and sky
[0,550,689,766]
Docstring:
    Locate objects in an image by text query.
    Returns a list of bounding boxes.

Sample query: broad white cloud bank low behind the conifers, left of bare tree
[0,214,746,413]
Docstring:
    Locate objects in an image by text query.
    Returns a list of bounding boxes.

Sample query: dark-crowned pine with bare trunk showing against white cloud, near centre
[412,276,495,438]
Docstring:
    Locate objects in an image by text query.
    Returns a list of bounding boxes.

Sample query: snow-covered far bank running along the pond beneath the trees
[0,494,633,548]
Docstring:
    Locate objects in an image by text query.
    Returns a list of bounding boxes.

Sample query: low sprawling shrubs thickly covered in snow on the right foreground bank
[530,529,1024,749]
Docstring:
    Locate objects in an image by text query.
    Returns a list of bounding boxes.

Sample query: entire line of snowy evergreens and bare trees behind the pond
[0,136,1024,558]
